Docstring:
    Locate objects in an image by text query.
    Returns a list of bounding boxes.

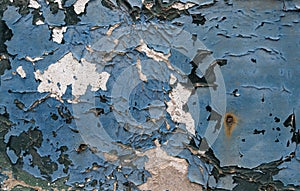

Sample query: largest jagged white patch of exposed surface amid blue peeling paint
[34,53,110,103]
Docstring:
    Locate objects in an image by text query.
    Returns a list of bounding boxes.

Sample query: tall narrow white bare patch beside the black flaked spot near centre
[167,83,195,135]
